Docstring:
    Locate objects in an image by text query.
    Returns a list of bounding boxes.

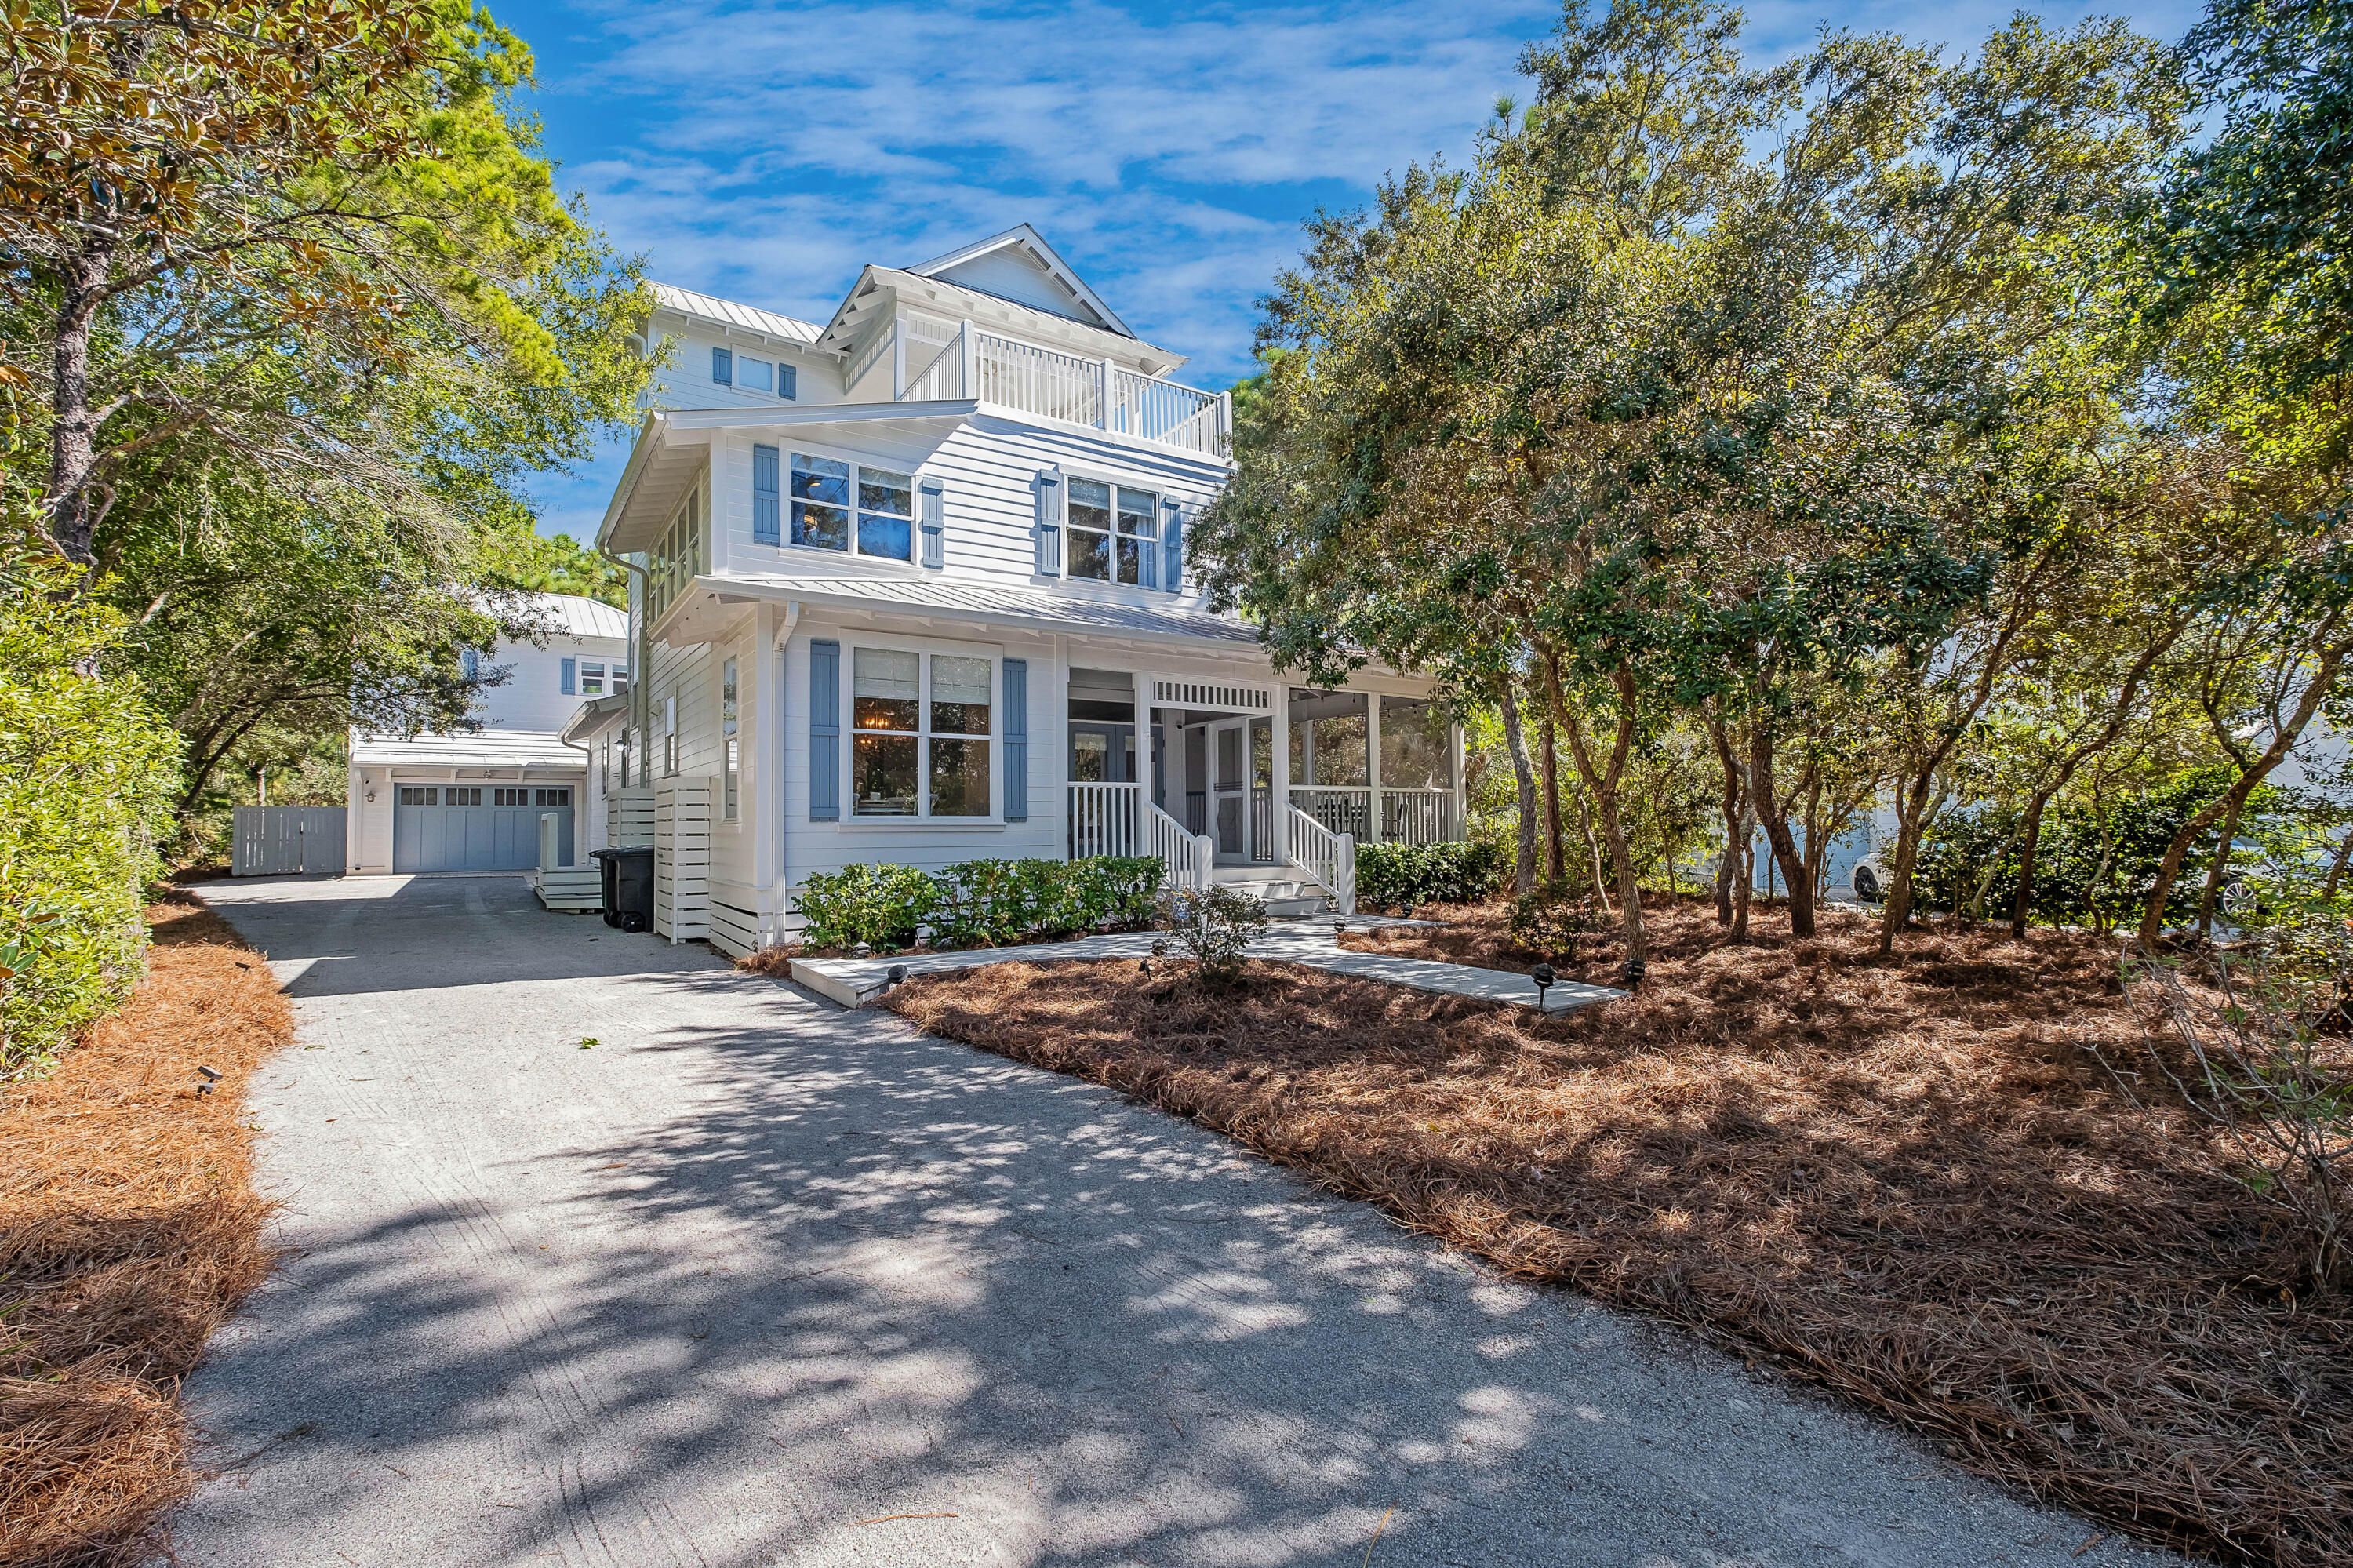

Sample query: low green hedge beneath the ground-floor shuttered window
[793,855,1162,954]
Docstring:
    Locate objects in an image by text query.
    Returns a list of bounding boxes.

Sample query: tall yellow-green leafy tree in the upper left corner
[0,0,642,565]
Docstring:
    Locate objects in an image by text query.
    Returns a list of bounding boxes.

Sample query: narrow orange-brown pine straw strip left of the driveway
[0,890,294,1568]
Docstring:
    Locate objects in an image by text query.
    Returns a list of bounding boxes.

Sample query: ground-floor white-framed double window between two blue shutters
[849,647,995,820]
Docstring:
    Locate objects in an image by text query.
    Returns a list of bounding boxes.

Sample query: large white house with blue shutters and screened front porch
[579,226,1464,951]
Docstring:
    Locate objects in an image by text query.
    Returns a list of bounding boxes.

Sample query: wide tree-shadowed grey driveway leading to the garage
[172,879,2174,1568]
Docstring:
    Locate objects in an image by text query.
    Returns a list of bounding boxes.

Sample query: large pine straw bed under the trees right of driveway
[889,902,2353,1568]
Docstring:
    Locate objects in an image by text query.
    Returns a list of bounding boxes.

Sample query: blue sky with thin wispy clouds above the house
[492,0,2198,539]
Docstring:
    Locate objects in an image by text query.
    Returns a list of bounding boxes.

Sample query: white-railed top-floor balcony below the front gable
[892,315,1233,461]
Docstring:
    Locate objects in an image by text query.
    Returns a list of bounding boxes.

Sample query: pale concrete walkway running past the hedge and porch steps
[793,916,1626,1013]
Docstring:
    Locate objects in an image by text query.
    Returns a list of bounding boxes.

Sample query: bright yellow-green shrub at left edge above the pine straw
[0,548,179,1081]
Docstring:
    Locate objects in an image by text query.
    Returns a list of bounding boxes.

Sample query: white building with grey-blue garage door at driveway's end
[344,593,628,874]
